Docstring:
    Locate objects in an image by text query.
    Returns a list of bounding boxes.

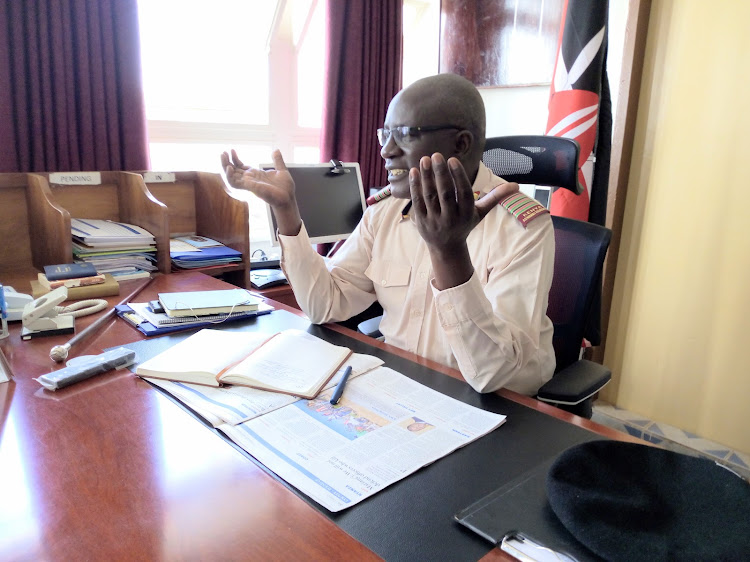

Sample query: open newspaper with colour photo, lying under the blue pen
[218,367,505,512]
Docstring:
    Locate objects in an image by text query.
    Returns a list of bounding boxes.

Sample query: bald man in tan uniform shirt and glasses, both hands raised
[222,74,555,395]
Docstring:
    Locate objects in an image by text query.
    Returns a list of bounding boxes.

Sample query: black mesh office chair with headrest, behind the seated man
[358,135,612,418]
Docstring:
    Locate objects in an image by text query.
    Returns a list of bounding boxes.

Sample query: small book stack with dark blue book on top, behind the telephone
[31,263,120,299]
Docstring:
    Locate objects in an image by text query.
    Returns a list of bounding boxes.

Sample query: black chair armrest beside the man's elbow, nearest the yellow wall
[536,359,612,405]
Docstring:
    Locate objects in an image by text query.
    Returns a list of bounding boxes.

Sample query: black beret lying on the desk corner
[547,441,750,561]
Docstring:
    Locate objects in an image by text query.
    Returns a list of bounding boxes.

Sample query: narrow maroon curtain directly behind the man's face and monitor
[320,0,402,191]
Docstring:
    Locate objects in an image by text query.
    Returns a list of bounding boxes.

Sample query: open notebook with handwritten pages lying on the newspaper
[136,329,352,400]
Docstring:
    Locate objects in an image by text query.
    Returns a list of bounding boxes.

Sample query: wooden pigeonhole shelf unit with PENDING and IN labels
[0,172,250,292]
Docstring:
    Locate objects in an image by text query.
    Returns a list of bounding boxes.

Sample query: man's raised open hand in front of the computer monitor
[221,149,302,236]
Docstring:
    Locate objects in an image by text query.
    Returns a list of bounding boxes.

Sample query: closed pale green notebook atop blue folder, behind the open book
[158,289,263,316]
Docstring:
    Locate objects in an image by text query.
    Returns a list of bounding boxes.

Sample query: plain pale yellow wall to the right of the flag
[603,0,750,451]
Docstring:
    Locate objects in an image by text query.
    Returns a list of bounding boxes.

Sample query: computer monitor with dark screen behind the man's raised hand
[261,162,366,246]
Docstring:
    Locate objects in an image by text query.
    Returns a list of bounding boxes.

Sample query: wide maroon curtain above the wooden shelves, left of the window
[0,0,149,172]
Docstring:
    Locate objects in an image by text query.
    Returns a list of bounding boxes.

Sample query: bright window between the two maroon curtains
[138,0,325,249]
